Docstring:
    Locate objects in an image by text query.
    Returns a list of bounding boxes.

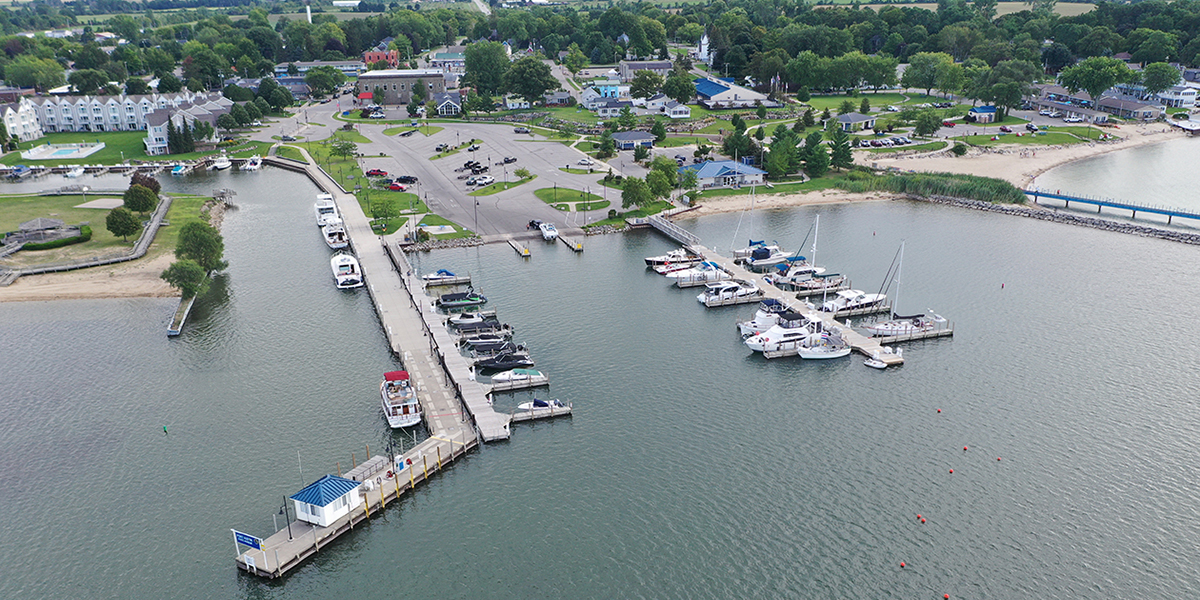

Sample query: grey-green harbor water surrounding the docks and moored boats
[0,163,1200,599]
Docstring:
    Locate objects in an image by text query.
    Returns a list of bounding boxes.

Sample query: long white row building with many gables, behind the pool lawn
[30,90,221,133]
